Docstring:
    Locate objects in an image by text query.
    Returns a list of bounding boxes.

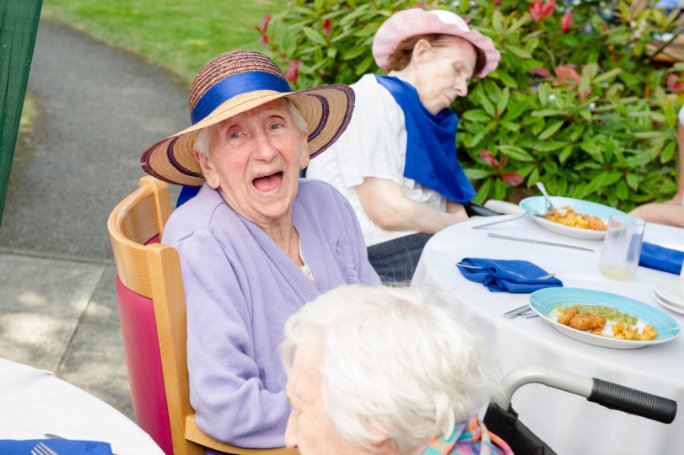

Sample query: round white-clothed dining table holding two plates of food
[411,214,684,454]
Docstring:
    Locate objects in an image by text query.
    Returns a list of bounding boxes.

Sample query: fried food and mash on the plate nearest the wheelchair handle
[554,305,658,341]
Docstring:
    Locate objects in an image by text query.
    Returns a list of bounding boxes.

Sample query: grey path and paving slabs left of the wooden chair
[0,22,188,418]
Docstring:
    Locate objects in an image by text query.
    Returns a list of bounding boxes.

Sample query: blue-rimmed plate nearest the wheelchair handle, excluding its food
[530,288,679,349]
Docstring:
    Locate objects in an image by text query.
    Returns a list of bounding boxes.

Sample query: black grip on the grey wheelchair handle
[587,378,677,423]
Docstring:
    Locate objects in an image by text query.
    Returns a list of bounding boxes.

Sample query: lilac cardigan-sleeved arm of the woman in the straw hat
[177,231,290,447]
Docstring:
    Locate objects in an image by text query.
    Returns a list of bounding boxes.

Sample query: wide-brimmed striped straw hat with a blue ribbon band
[140,50,354,186]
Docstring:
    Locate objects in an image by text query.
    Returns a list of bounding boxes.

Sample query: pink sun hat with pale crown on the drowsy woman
[373,8,501,77]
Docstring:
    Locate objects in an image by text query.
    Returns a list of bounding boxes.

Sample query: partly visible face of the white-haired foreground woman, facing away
[285,342,382,455]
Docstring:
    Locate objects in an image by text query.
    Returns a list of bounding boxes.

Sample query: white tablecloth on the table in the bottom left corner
[0,358,164,455]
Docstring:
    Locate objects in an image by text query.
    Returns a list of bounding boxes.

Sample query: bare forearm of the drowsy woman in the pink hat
[356,177,468,234]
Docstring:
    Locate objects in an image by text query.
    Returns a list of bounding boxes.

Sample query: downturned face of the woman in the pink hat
[413,36,477,114]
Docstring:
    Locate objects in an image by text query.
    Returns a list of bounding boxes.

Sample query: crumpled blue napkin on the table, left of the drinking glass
[456,258,563,294]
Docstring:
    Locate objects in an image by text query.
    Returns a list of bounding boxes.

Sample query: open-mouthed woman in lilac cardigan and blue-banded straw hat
[142,50,379,447]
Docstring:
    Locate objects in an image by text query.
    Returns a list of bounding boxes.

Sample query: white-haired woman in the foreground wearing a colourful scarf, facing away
[280,285,512,455]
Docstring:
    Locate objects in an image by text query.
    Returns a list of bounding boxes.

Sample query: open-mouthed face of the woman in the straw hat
[197,99,309,227]
